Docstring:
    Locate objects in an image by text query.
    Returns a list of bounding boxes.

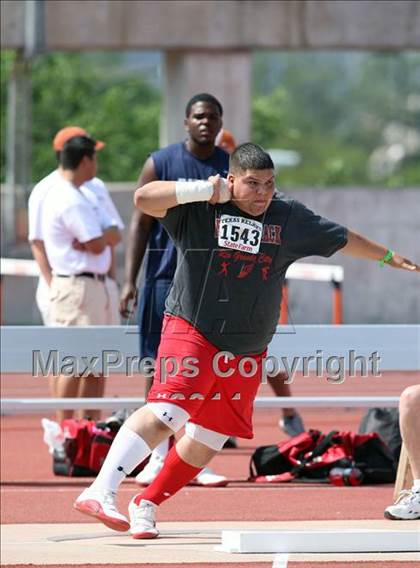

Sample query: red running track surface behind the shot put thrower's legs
[1,373,419,568]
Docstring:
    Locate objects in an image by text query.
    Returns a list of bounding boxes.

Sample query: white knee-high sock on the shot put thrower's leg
[91,425,152,491]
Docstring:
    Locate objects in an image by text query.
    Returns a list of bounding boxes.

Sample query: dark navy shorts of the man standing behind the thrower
[137,279,172,359]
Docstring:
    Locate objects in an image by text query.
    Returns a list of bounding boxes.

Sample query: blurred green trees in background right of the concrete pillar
[252,52,420,187]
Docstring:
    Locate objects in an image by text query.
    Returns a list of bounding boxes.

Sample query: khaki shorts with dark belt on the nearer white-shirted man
[49,276,109,326]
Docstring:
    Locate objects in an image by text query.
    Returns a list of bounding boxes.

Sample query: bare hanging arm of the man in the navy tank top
[120,157,157,318]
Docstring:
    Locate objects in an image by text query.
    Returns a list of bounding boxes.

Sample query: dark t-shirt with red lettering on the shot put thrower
[161,193,347,355]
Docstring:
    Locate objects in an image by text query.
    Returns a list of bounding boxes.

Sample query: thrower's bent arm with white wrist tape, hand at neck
[134,175,225,218]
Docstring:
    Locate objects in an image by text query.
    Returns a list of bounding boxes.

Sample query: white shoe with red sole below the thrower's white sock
[73,487,130,532]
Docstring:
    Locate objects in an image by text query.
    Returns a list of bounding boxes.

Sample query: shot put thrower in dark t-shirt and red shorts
[74,143,420,539]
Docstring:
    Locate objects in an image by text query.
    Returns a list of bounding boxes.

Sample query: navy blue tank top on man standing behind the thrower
[146,142,229,283]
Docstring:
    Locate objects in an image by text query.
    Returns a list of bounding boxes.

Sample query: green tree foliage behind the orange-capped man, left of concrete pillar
[1,53,160,181]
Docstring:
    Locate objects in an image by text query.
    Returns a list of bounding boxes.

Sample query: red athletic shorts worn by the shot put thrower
[147,316,266,438]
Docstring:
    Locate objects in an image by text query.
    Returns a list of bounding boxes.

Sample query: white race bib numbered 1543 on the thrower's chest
[218,215,263,254]
